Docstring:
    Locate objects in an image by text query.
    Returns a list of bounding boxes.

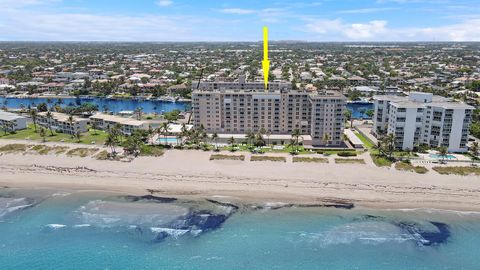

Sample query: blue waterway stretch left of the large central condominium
[0,97,190,113]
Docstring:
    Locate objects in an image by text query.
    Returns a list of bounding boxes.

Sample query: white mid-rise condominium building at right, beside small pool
[373,92,474,152]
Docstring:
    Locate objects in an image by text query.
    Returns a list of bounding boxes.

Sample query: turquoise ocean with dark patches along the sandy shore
[0,189,480,270]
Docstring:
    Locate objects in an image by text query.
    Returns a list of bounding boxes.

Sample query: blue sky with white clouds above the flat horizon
[0,0,480,42]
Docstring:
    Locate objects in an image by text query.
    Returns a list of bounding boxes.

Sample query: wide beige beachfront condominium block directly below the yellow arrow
[192,87,346,146]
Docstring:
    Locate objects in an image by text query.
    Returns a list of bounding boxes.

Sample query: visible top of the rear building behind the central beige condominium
[192,75,292,91]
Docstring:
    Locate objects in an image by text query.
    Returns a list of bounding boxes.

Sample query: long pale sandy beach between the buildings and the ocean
[0,140,480,211]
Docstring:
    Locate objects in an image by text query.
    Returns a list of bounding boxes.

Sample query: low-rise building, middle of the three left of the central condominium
[37,112,88,134]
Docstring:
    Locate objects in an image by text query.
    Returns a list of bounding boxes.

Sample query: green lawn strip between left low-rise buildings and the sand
[0,124,108,145]
